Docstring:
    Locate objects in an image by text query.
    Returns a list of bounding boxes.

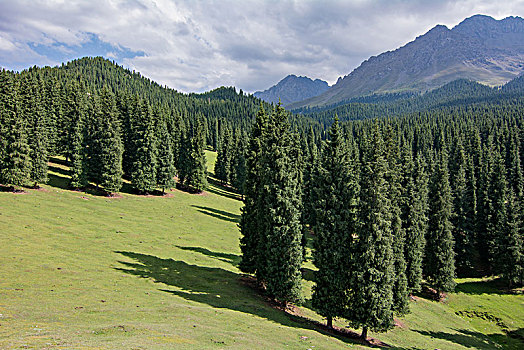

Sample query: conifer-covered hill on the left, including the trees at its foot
[0,57,282,193]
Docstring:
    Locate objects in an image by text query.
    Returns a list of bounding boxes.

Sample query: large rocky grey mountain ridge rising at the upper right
[289,15,524,108]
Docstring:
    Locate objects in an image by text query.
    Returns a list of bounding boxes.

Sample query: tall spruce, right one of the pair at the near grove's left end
[257,104,303,304]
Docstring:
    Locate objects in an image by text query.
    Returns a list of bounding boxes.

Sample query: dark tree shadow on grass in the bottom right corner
[414,329,524,349]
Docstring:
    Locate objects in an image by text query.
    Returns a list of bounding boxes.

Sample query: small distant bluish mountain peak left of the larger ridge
[253,74,329,106]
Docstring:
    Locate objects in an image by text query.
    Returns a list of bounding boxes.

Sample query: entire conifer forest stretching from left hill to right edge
[0,58,524,338]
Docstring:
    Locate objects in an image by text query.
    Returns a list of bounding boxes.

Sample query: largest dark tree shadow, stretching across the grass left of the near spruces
[115,252,384,344]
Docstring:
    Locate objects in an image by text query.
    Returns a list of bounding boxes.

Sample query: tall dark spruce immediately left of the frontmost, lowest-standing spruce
[311,118,358,328]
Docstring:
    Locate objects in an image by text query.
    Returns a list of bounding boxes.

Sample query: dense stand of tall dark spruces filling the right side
[240,99,524,337]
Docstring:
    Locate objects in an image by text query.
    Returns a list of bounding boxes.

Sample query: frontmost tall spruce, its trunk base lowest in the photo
[346,124,394,339]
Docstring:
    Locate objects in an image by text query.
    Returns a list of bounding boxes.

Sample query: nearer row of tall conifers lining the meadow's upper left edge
[0,69,207,193]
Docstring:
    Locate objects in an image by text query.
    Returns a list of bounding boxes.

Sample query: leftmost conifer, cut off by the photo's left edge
[0,70,30,186]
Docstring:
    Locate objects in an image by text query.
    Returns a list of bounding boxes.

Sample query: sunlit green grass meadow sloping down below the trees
[0,152,524,349]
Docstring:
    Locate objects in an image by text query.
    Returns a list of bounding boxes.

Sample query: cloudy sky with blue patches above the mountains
[0,0,524,92]
